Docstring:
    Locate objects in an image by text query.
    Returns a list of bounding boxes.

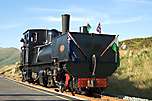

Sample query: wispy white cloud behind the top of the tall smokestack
[28,5,109,22]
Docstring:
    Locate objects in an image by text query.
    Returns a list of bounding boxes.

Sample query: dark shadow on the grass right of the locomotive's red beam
[105,76,152,99]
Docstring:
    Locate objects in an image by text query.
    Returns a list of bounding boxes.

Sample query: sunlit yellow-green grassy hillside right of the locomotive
[106,37,152,99]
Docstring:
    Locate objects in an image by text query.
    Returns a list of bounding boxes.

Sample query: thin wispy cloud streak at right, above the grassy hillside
[103,16,143,25]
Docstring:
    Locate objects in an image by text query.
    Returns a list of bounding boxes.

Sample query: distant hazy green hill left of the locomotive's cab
[0,48,20,68]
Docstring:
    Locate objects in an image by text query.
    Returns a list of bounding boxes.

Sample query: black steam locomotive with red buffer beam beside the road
[20,14,119,93]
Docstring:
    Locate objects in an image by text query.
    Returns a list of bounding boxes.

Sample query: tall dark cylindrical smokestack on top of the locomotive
[62,14,70,33]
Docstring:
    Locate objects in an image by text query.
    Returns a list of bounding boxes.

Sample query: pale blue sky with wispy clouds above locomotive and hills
[0,0,152,48]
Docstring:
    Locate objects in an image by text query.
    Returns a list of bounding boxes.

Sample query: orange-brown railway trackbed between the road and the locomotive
[0,75,152,101]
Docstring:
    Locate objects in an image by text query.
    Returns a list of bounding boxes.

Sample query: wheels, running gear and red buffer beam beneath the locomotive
[20,62,108,94]
